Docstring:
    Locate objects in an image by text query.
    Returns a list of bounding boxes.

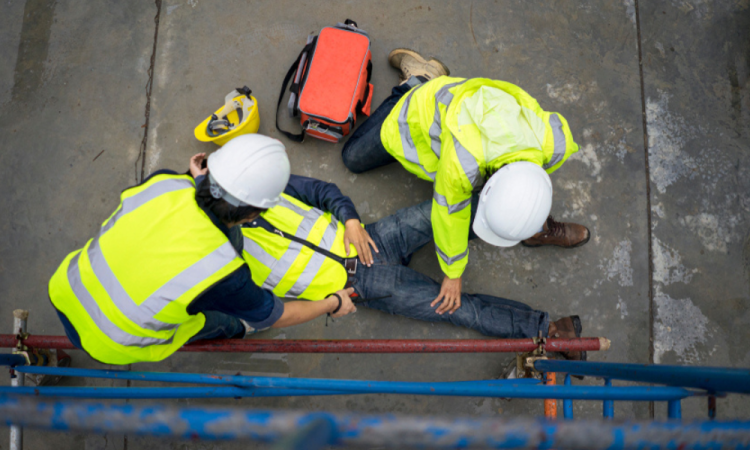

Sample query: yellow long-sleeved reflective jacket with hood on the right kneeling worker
[380,77,578,278]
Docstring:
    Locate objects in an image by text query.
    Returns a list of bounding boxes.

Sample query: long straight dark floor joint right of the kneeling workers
[635,0,654,419]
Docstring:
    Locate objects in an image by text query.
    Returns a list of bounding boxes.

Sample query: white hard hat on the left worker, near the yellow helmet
[208,134,290,209]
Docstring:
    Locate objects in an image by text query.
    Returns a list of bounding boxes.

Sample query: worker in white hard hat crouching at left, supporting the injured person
[49,134,355,364]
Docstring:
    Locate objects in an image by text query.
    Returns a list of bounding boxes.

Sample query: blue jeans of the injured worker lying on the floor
[354,200,549,338]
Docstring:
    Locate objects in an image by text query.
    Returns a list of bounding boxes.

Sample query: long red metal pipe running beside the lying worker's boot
[0,334,609,353]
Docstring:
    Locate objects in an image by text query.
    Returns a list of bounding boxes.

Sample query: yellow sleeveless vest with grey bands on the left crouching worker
[49,175,244,364]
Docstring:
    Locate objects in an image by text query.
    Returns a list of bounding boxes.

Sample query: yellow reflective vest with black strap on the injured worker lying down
[242,194,357,300]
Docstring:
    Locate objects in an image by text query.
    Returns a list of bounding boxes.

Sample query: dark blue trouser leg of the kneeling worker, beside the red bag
[341,81,423,173]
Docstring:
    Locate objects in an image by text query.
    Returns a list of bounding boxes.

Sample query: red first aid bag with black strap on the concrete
[276,19,372,142]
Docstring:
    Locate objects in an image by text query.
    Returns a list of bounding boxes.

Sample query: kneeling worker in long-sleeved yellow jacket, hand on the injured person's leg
[342,49,590,314]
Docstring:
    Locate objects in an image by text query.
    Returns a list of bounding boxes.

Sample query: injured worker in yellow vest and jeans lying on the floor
[242,175,586,359]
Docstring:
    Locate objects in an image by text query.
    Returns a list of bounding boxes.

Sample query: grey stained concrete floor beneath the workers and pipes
[0,0,750,450]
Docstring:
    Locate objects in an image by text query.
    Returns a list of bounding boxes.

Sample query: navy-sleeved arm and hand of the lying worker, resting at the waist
[284,175,379,266]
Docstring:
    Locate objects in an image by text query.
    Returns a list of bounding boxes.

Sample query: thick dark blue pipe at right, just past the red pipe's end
[534,359,750,394]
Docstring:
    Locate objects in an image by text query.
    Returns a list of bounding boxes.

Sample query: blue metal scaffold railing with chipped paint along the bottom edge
[0,355,750,449]
